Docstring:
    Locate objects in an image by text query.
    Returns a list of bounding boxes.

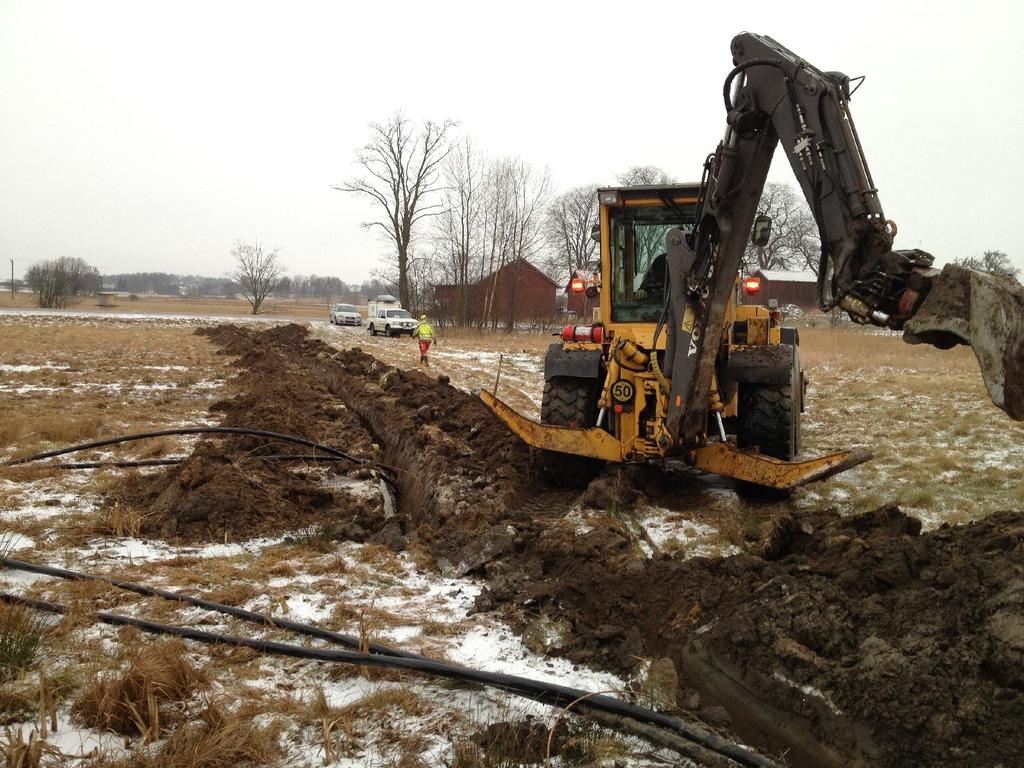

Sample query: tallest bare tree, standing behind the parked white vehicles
[334,113,455,307]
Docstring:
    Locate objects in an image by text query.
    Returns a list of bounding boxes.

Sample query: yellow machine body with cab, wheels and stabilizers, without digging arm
[481,183,862,488]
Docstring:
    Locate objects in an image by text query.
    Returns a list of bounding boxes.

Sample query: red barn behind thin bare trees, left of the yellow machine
[434,259,558,327]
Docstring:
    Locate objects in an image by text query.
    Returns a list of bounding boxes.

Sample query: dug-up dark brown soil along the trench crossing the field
[112,325,1024,766]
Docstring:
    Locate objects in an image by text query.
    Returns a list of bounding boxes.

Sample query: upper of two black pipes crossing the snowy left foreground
[0,557,425,658]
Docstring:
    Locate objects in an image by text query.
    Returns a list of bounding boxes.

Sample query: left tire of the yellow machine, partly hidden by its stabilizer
[539,376,603,487]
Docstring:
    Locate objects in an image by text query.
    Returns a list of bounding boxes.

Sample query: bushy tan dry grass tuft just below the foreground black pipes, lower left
[72,640,210,737]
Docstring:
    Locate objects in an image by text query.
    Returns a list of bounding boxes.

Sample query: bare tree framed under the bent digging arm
[743,181,821,273]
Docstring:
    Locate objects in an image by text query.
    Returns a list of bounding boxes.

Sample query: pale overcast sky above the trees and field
[0,0,1024,281]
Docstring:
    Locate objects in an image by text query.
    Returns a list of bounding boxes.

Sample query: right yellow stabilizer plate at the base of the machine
[690,442,871,489]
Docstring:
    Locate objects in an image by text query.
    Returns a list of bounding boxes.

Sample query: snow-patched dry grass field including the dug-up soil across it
[0,309,1024,767]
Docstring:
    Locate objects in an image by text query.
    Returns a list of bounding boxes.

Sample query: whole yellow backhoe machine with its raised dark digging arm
[480,33,1024,492]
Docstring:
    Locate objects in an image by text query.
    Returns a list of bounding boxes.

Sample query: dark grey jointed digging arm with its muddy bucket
[666,33,1024,445]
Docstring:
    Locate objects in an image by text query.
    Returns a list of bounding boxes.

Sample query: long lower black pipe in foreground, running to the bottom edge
[0,593,778,768]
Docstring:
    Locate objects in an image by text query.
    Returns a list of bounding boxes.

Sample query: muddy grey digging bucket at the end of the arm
[903,264,1024,421]
